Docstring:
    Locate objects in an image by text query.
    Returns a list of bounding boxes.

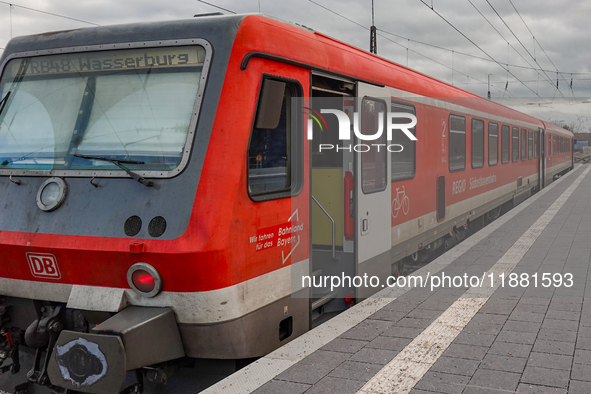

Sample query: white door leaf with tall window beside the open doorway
[352,82,392,299]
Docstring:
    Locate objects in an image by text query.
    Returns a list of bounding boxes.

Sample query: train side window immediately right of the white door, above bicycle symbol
[390,102,417,182]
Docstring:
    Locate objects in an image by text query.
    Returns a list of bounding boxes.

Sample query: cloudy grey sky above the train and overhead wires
[0,0,591,132]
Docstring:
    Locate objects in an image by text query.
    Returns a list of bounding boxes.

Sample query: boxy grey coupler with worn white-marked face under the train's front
[47,307,185,394]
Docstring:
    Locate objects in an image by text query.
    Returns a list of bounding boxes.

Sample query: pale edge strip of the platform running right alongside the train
[202,165,581,394]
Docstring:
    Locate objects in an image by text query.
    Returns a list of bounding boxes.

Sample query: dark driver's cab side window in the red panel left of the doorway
[248,77,302,201]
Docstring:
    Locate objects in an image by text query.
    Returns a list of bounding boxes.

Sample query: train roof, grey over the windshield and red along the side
[0,14,572,136]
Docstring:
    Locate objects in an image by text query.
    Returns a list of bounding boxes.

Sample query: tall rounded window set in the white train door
[361,98,388,194]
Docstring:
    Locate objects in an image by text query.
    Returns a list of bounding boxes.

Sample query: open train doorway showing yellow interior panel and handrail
[307,72,355,325]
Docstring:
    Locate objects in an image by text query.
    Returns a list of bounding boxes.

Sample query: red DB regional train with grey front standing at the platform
[0,15,573,393]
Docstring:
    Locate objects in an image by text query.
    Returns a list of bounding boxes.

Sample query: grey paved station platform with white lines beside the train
[204,165,591,394]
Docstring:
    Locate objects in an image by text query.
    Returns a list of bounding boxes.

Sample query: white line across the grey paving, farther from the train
[358,167,591,394]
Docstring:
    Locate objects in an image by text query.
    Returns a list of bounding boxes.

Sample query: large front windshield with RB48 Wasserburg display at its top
[0,46,205,172]
